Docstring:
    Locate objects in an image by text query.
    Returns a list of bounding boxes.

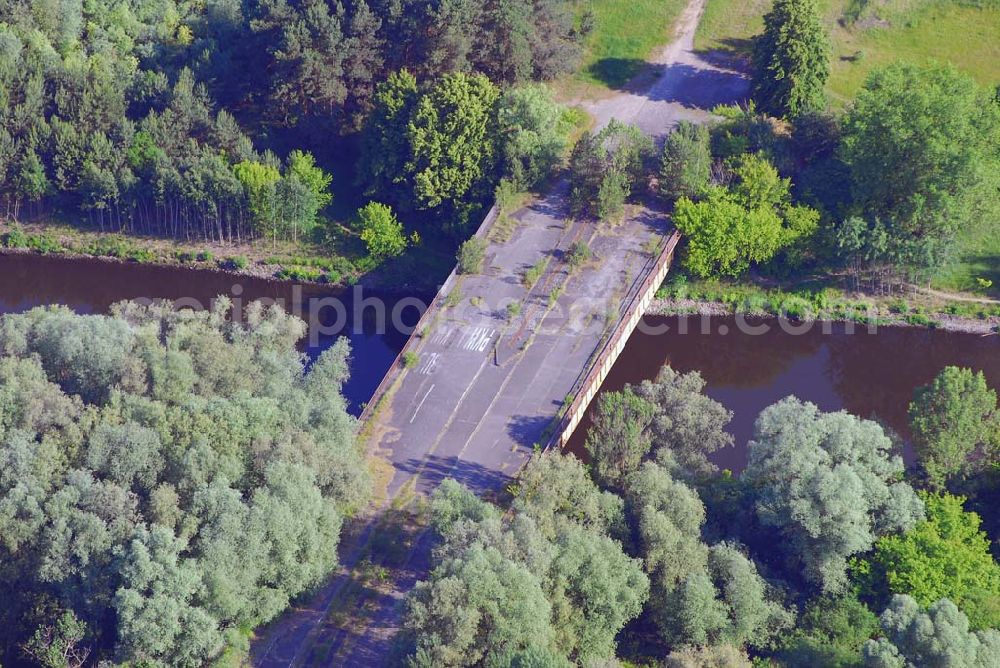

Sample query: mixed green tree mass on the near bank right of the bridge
[398,367,1000,668]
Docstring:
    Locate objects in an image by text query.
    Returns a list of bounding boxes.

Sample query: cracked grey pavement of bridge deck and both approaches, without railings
[251,0,746,666]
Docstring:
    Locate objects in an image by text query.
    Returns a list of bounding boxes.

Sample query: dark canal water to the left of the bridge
[0,254,421,414]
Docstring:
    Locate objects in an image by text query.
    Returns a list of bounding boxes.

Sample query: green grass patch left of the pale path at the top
[566,0,687,93]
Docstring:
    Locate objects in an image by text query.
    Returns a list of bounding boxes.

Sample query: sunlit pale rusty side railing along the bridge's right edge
[543,232,681,449]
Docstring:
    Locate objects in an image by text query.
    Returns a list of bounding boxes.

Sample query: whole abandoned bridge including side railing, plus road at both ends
[251,0,747,666]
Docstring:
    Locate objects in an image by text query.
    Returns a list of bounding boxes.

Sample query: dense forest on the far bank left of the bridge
[0,0,589,241]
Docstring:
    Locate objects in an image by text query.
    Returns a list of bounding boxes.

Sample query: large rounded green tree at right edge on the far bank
[842,63,1000,269]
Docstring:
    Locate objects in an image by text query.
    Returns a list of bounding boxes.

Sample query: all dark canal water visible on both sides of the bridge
[0,254,1000,462]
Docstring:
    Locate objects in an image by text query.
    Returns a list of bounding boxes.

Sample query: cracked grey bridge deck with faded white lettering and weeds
[372,187,667,497]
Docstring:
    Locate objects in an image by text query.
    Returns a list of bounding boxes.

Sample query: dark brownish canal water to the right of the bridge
[568,316,1000,472]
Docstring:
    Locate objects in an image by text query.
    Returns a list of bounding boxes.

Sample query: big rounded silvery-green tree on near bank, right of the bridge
[743,397,924,592]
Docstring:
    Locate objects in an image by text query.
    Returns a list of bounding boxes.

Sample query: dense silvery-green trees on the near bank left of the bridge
[0,299,370,667]
